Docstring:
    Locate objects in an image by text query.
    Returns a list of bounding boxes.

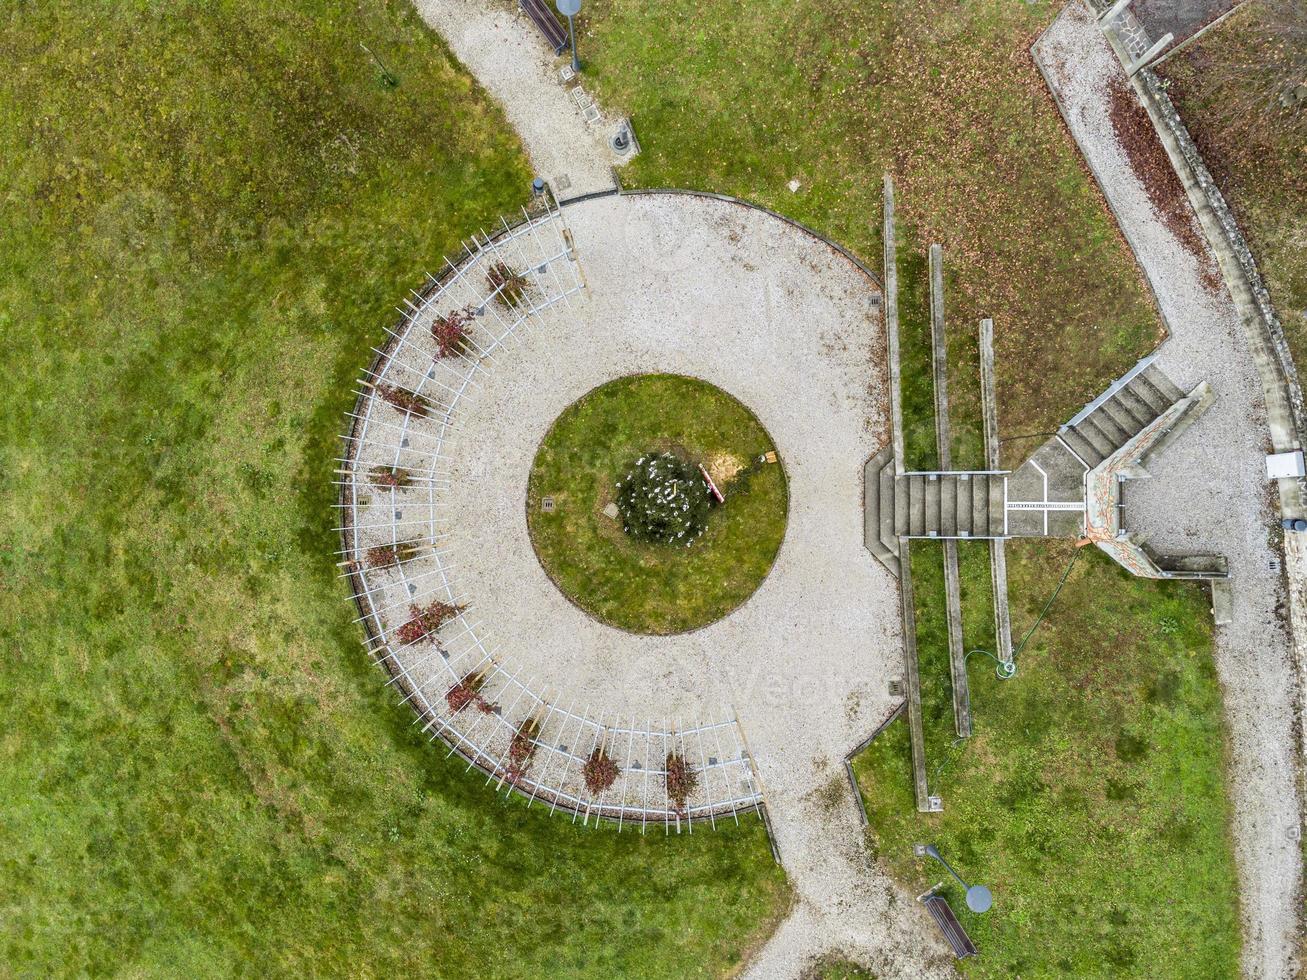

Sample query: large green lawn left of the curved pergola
[0,0,788,977]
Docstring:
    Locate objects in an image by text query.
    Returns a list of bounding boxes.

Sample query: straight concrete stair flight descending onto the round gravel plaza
[863,447,1006,575]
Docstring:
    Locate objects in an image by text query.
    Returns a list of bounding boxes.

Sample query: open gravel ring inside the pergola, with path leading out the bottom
[446,195,951,976]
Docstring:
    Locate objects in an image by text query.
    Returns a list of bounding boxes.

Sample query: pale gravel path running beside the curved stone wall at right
[1035,3,1302,977]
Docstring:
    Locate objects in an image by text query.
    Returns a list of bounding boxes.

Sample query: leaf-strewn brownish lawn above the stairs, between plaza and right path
[580,0,1161,452]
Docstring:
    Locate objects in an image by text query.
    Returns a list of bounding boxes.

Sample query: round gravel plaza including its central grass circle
[346,193,903,832]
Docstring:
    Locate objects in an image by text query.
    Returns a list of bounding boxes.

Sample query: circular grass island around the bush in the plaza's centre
[527,374,789,634]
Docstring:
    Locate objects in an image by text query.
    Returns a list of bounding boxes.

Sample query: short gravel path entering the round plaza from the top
[414,0,618,200]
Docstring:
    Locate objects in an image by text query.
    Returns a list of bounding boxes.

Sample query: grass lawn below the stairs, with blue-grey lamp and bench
[853,542,1239,977]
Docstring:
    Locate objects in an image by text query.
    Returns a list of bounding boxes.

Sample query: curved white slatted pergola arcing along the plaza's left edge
[340,200,762,828]
